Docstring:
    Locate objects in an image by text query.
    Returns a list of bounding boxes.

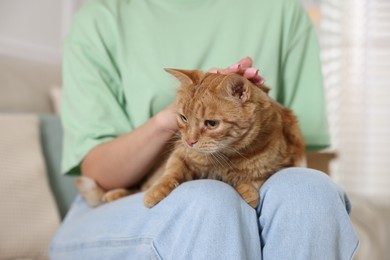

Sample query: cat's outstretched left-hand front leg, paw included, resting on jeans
[144,151,188,208]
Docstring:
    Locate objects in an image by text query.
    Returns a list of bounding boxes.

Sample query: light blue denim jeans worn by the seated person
[50,168,358,260]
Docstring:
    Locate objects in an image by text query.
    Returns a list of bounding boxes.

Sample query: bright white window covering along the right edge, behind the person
[318,0,390,205]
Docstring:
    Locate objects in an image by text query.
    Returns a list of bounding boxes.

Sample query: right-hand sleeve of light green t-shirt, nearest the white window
[281,2,330,151]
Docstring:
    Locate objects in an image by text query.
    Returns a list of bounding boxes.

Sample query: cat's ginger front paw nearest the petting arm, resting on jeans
[144,179,179,208]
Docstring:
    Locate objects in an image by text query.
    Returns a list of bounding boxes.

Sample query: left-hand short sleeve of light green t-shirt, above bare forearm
[61,5,132,175]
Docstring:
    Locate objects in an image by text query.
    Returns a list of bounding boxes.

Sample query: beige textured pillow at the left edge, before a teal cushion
[0,114,60,259]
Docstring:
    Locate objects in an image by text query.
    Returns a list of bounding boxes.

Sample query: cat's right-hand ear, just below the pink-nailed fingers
[223,74,250,102]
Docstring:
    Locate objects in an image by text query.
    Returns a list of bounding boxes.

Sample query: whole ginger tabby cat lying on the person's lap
[78,69,305,208]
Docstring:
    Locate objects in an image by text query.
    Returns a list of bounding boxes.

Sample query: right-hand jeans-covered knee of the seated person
[258,168,357,259]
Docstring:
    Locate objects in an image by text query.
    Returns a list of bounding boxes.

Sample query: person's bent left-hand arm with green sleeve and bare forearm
[61,8,177,190]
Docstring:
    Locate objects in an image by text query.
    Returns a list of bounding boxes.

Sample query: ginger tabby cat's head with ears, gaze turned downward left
[166,69,270,154]
